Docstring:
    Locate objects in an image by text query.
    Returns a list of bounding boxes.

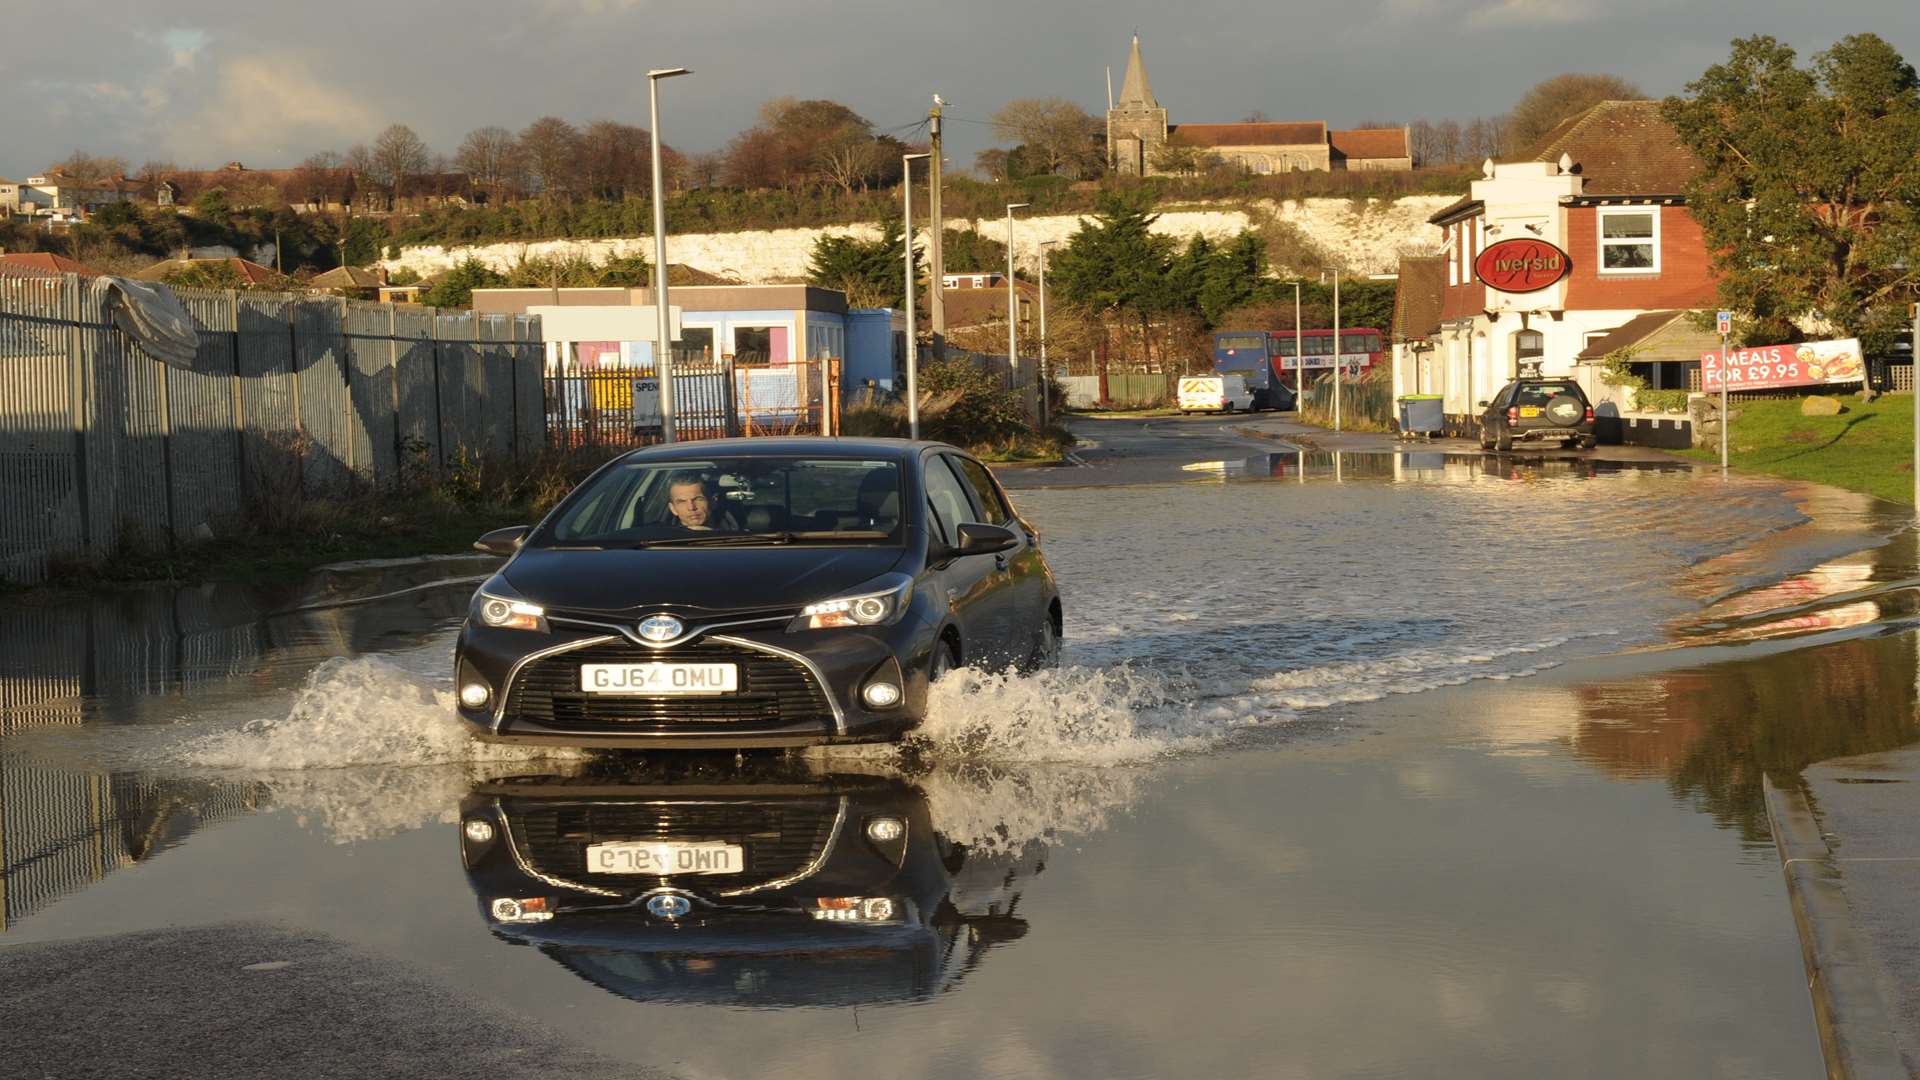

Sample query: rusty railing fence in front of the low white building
[545,359,841,448]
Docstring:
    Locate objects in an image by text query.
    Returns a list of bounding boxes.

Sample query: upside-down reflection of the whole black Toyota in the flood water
[461,763,1027,1007]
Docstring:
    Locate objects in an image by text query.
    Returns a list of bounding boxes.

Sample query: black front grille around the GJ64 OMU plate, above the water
[505,642,833,734]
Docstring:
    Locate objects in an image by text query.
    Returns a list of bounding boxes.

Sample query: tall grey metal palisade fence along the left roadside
[0,275,545,582]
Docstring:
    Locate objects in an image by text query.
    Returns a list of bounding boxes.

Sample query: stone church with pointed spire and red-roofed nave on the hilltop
[1106,35,1413,177]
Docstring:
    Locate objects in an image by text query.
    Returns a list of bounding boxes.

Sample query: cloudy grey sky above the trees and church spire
[0,0,1920,179]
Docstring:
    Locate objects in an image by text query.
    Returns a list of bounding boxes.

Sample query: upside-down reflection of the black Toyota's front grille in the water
[501,796,841,892]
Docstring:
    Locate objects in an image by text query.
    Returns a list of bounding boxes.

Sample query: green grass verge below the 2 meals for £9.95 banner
[1678,394,1914,503]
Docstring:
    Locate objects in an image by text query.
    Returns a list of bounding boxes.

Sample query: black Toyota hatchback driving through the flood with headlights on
[455,438,1060,748]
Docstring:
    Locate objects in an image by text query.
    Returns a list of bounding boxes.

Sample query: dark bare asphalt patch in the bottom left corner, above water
[0,922,660,1080]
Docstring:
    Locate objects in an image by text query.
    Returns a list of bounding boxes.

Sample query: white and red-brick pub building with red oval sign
[1394,102,1716,436]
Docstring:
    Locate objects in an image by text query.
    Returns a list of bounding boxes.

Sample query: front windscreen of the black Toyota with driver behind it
[528,455,904,548]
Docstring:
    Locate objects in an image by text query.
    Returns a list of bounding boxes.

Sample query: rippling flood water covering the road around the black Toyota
[0,441,1920,1078]
